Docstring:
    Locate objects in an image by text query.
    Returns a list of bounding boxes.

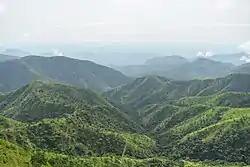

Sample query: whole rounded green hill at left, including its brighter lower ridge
[0,81,155,157]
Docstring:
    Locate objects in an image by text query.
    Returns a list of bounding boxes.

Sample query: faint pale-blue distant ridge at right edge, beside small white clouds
[207,52,250,65]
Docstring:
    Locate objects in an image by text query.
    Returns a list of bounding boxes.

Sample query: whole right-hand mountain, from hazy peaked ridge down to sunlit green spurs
[105,74,250,164]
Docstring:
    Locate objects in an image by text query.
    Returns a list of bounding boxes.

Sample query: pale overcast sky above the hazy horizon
[0,0,250,44]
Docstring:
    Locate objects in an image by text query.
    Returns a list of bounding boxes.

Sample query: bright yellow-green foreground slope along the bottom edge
[0,139,249,167]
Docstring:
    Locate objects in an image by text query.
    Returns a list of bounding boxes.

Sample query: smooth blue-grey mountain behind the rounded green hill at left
[0,56,130,92]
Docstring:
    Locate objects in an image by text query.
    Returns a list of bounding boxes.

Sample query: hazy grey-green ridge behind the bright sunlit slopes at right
[104,74,250,109]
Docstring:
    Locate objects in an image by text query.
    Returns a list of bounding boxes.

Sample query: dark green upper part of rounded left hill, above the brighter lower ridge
[0,81,137,131]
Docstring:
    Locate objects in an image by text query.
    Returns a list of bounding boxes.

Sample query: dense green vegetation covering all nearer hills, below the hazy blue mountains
[0,74,250,167]
